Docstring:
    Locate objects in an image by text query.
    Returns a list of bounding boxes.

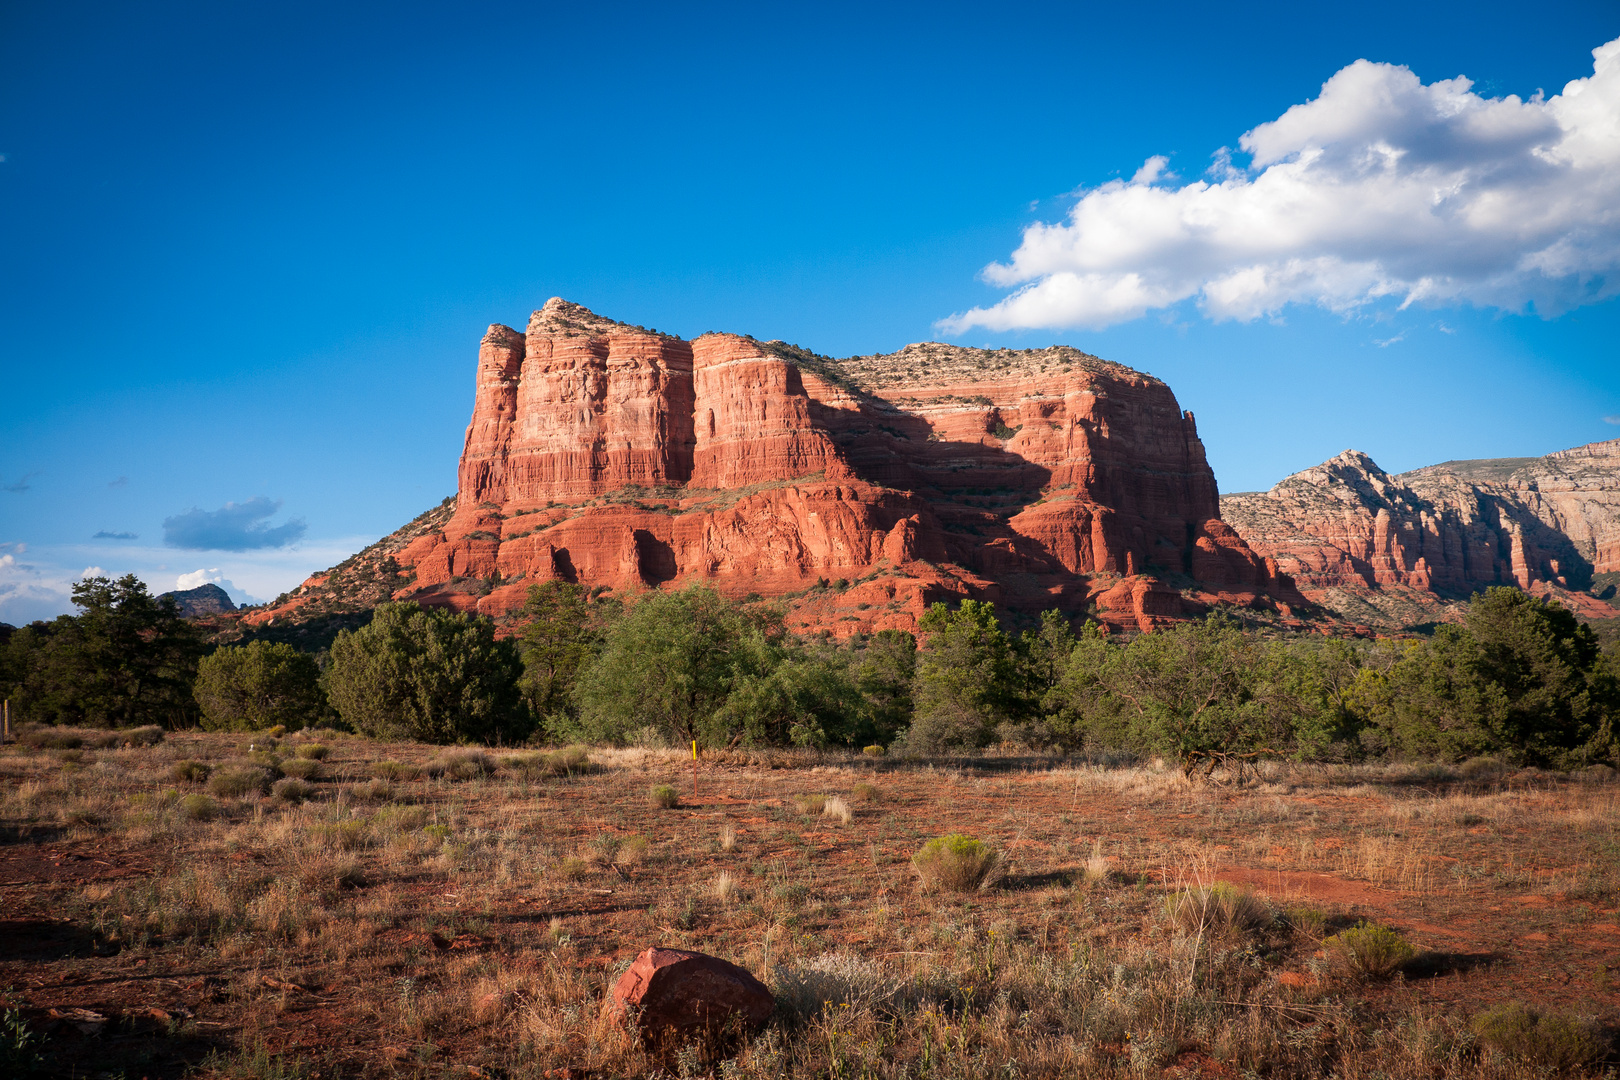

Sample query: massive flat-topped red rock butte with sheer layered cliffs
[246,300,1302,636]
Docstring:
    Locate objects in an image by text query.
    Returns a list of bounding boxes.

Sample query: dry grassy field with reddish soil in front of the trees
[0,732,1620,1080]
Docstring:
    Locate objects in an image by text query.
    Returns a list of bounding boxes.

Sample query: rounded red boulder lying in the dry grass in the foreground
[604,949,776,1051]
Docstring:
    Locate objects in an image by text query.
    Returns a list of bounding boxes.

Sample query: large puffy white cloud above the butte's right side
[940,39,1620,334]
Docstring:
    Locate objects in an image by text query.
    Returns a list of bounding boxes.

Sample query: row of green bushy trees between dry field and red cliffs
[0,576,1620,767]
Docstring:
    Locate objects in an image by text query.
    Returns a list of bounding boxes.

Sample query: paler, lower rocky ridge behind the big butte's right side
[1221,440,1620,625]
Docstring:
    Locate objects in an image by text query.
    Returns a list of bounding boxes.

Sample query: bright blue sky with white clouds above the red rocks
[0,0,1620,623]
